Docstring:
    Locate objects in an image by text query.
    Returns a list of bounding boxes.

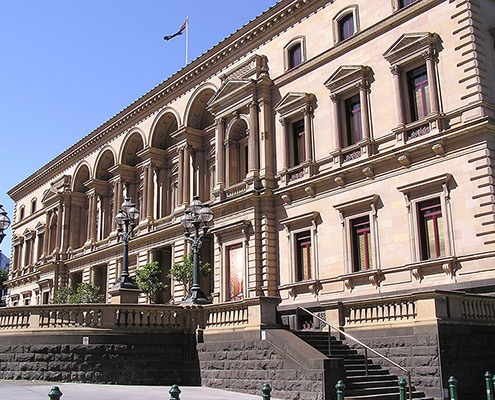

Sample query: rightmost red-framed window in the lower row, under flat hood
[418,197,445,260]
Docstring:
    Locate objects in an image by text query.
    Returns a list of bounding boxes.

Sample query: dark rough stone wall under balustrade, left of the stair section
[0,334,199,385]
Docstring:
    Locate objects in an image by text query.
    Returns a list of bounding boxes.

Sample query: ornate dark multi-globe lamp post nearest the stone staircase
[180,196,213,304]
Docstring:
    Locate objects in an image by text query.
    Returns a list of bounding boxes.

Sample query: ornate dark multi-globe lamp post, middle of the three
[113,197,139,289]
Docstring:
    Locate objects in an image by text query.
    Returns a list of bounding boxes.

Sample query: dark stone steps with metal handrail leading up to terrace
[293,331,433,400]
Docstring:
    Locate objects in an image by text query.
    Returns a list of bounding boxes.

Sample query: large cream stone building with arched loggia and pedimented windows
[3,0,495,398]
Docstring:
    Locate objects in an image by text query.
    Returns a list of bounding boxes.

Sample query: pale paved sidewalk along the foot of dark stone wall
[0,380,275,400]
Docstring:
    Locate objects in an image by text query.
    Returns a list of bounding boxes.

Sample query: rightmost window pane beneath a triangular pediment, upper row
[407,65,430,121]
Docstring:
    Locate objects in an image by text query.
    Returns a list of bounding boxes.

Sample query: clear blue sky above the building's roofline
[0,0,275,254]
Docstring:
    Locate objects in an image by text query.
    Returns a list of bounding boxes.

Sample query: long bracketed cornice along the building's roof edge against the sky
[7,0,335,201]
